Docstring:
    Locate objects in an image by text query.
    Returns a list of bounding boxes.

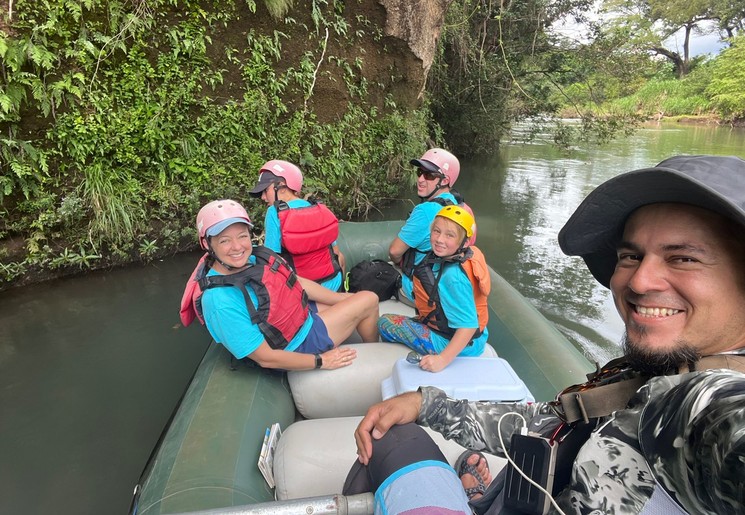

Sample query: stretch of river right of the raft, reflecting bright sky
[457,124,745,362]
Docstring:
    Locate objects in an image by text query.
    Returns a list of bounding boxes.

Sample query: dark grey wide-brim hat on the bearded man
[559,155,745,287]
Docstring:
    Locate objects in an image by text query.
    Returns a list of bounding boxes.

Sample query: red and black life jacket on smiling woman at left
[181,247,308,349]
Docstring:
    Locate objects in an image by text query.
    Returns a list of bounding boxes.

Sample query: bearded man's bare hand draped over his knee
[354,392,422,465]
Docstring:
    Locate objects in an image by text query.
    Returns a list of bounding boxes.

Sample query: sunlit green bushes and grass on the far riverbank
[556,26,745,124]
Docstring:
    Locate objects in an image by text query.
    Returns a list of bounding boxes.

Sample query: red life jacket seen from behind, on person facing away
[274,200,341,282]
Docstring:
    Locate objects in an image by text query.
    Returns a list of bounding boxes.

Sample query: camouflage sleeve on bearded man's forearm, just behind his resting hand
[417,386,550,456]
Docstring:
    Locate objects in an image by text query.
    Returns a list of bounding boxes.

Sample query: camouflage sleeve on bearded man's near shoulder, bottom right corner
[639,370,745,513]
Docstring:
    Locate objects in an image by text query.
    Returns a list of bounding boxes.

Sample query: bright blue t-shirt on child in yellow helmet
[424,264,489,356]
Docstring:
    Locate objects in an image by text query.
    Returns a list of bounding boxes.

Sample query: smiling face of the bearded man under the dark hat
[610,204,745,360]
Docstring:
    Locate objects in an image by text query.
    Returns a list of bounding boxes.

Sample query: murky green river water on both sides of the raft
[0,124,745,514]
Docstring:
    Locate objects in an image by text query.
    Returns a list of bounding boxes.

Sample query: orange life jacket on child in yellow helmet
[412,247,491,340]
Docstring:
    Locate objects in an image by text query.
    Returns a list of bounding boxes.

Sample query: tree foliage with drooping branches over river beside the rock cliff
[428,0,648,155]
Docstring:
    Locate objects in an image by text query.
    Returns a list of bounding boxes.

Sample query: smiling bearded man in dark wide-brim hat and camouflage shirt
[348,156,745,514]
